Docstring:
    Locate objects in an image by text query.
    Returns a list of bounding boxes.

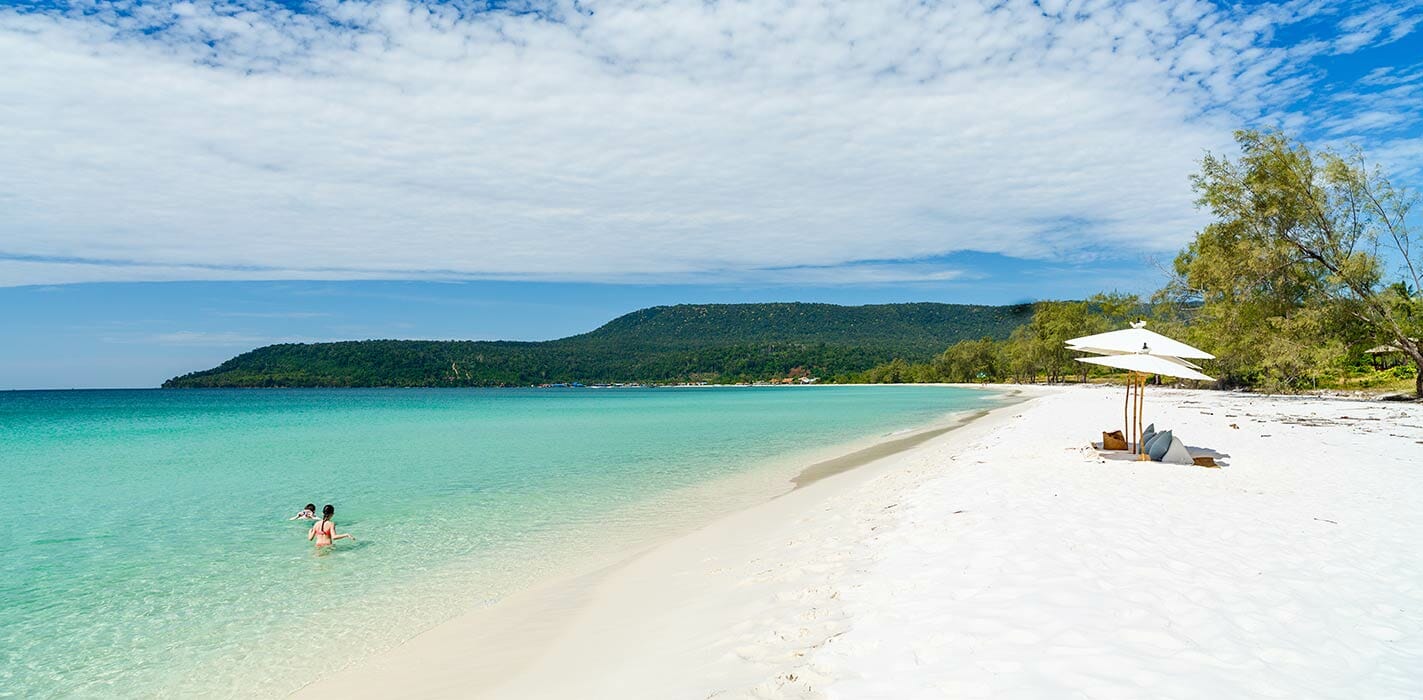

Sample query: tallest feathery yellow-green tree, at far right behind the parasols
[1164,131,1423,397]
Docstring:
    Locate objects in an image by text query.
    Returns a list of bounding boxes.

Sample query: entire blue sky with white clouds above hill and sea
[0,0,1423,388]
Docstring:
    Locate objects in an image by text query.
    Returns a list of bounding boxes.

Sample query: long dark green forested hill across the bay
[164,303,1033,388]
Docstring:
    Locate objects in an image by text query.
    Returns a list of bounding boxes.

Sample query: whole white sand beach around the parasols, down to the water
[299,387,1423,699]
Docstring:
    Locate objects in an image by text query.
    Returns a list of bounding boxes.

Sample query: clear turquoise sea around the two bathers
[0,387,996,697]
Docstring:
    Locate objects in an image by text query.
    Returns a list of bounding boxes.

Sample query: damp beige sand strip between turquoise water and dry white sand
[290,384,1050,697]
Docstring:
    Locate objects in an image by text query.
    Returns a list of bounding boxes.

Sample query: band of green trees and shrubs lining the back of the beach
[864,131,1423,397]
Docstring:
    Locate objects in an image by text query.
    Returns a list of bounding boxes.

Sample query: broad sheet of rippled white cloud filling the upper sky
[0,0,1402,285]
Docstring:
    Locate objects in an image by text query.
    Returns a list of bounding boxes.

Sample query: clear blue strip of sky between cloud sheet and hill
[0,255,1144,388]
